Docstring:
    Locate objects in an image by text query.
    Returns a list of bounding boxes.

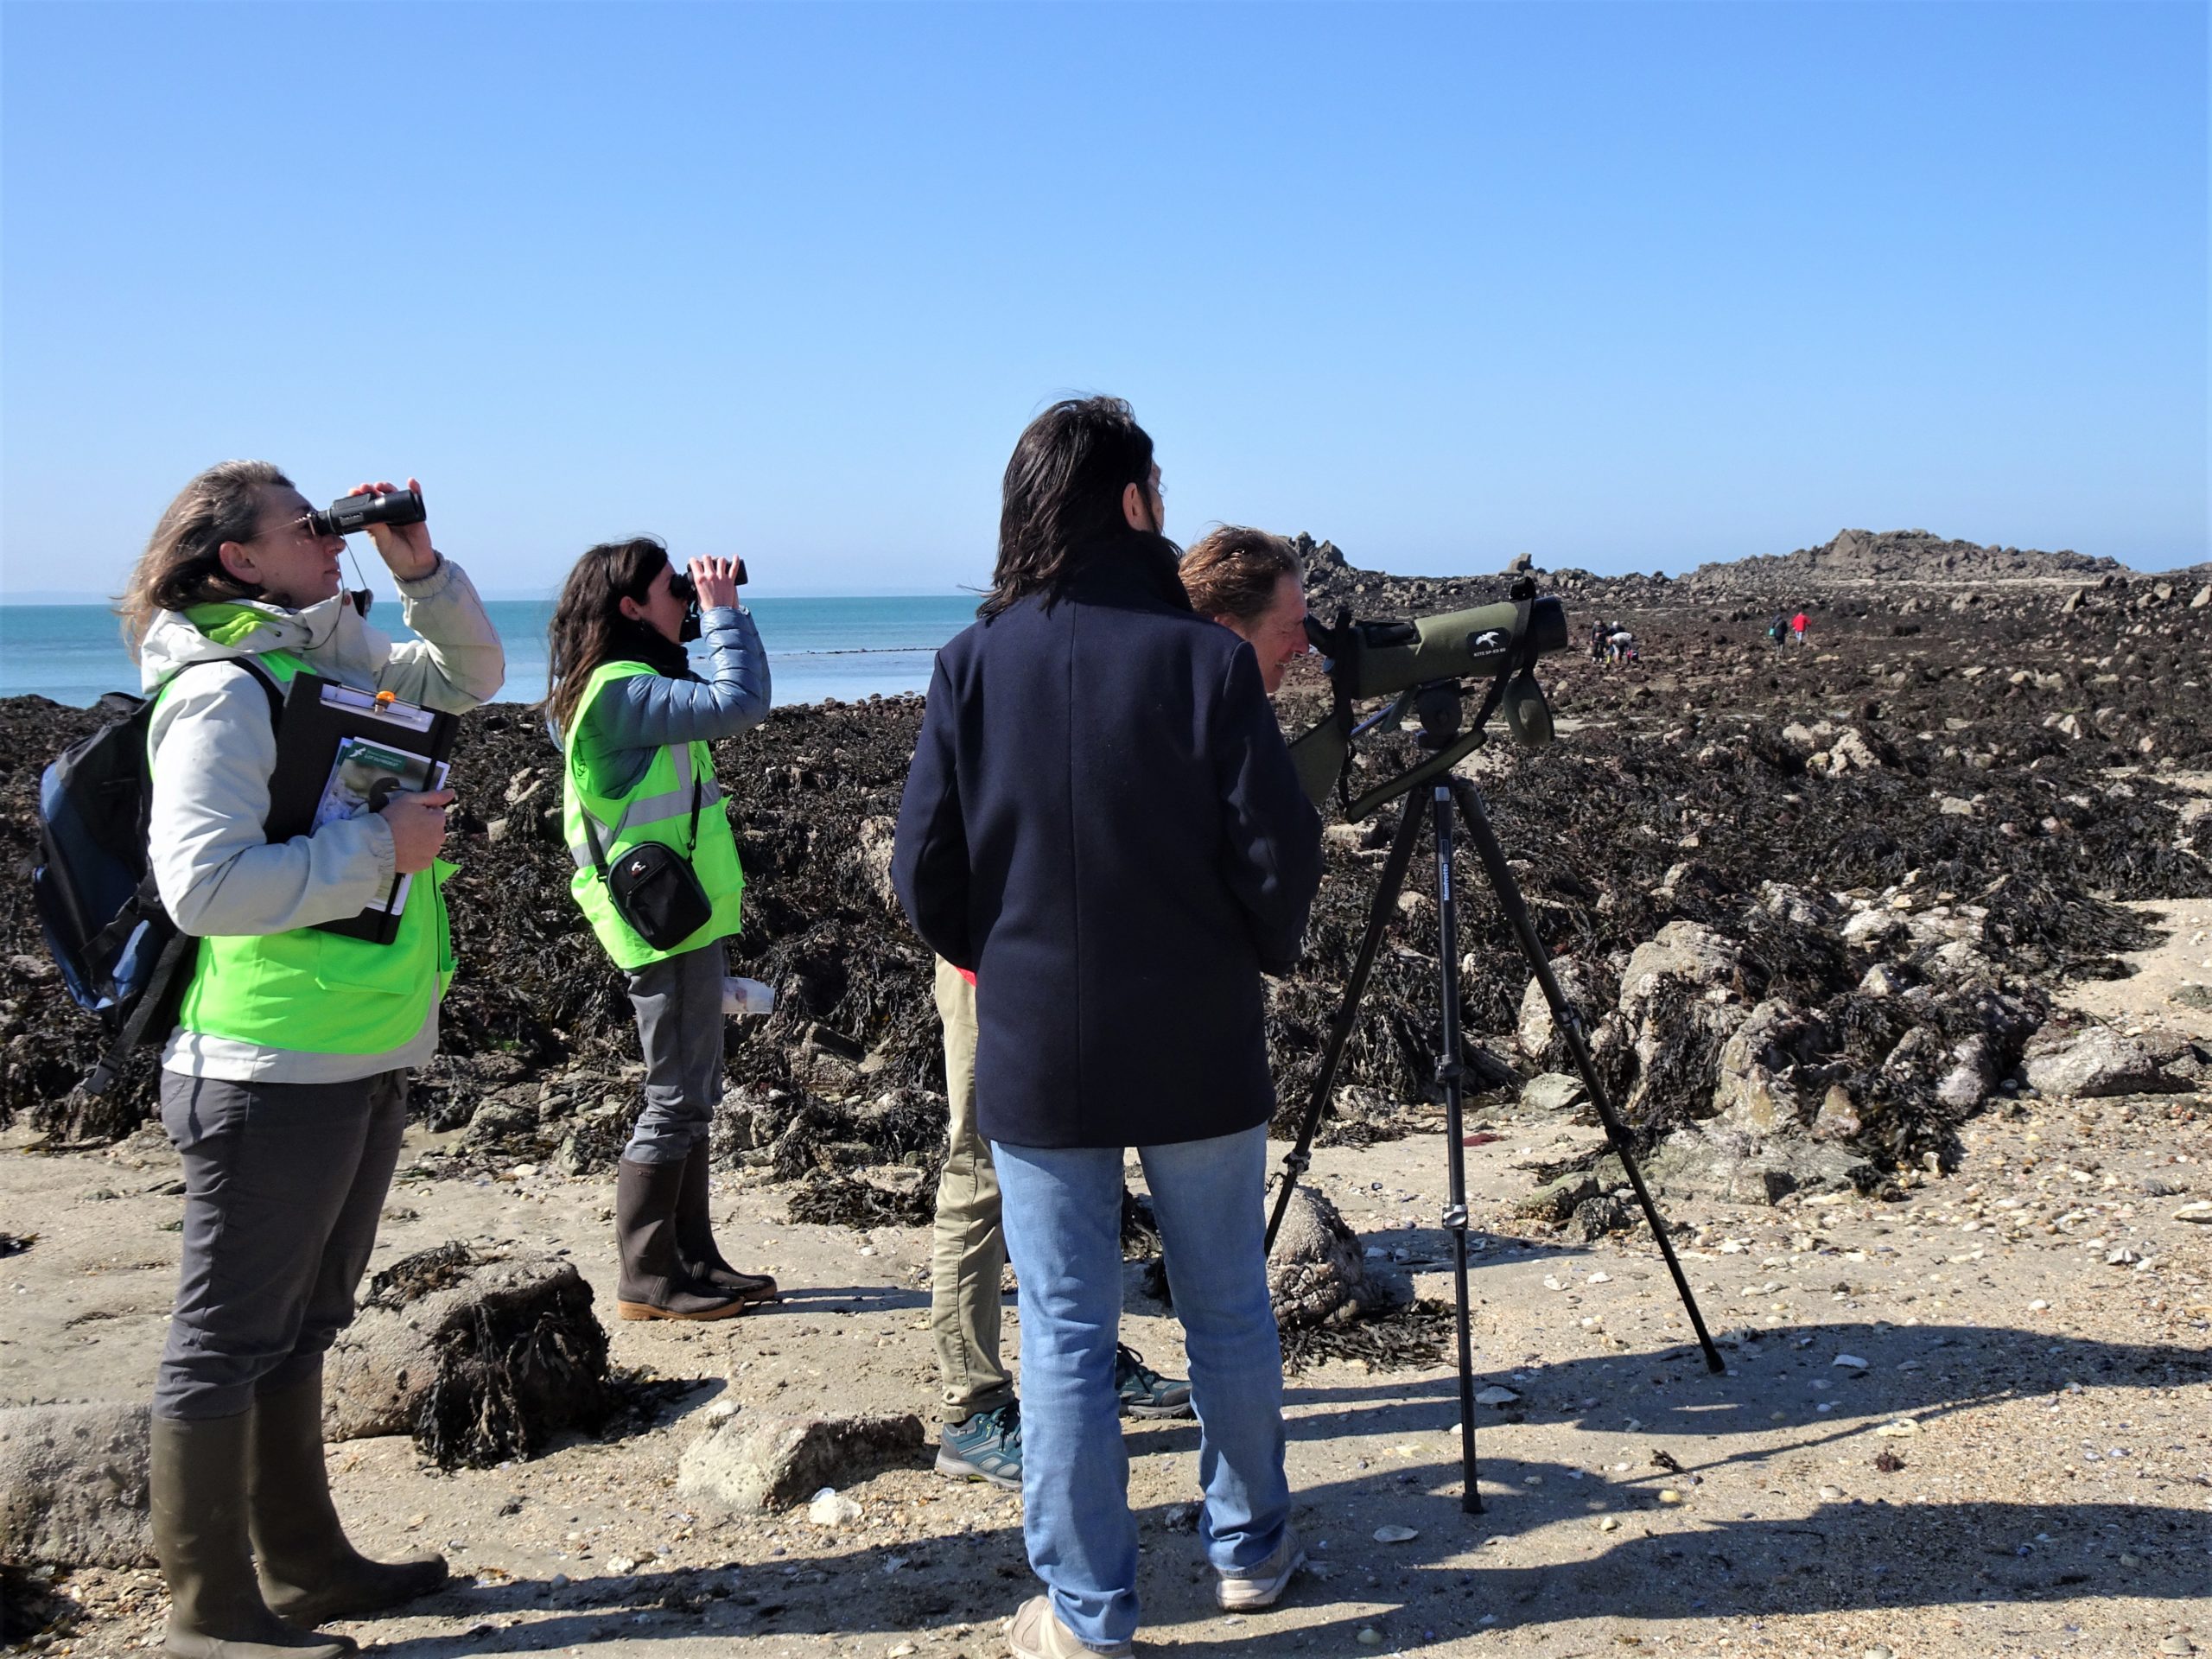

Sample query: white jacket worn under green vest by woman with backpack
[139,557,506,1084]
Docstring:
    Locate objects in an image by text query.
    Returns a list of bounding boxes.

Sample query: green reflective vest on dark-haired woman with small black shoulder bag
[562,661,746,969]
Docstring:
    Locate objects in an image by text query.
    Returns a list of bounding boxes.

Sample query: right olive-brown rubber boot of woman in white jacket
[245,1363,445,1624]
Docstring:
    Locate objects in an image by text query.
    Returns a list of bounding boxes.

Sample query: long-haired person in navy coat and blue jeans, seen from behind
[892,398,1320,1659]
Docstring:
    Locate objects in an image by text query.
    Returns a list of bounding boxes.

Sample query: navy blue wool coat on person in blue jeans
[892,533,1320,1146]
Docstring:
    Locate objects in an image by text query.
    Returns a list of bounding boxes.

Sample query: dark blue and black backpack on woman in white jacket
[31,657,283,1095]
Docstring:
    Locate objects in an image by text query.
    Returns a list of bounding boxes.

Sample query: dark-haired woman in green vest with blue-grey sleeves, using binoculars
[546,537,777,1319]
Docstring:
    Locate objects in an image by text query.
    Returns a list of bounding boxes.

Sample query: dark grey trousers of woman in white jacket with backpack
[153,1071,407,1418]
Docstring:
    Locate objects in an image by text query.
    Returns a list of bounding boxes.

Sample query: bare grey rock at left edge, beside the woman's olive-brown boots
[0,1402,153,1566]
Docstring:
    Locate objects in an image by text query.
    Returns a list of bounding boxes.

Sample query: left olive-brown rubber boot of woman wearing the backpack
[149,1411,359,1659]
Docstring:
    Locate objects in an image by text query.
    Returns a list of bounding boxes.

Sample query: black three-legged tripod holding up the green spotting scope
[1268,679,1726,1516]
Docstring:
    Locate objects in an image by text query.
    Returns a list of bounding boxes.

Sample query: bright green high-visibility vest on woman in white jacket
[155,641,454,1055]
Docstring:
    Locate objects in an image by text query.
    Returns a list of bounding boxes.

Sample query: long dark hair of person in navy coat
[978,398,1153,617]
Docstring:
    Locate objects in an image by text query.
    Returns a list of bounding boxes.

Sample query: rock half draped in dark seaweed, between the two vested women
[323,1243,617,1469]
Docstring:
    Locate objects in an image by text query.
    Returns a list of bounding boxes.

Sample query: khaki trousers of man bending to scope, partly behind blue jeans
[929,960,1013,1422]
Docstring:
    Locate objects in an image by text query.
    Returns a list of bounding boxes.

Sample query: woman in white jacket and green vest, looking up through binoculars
[119,460,506,1659]
